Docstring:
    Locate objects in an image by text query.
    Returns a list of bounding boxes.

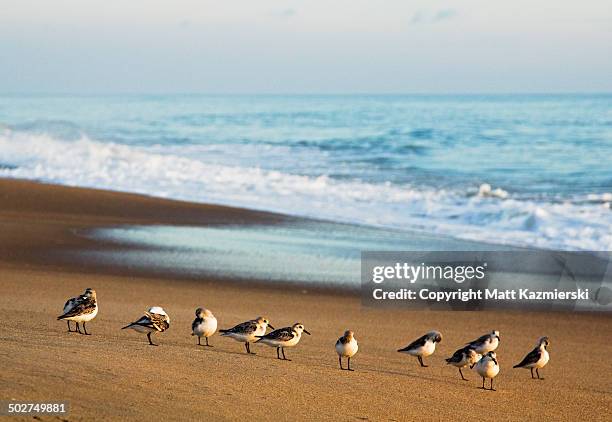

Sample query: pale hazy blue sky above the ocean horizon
[0,0,612,94]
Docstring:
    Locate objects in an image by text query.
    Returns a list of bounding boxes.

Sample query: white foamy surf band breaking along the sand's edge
[0,128,612,250]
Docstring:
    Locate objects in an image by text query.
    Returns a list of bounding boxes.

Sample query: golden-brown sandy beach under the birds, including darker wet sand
[0,180,612,421]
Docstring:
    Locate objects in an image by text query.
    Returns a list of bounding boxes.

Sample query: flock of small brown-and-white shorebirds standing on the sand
[57,288,549,391]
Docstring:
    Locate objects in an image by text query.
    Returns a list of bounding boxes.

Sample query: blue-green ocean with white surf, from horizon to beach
[0,95,612,250]
